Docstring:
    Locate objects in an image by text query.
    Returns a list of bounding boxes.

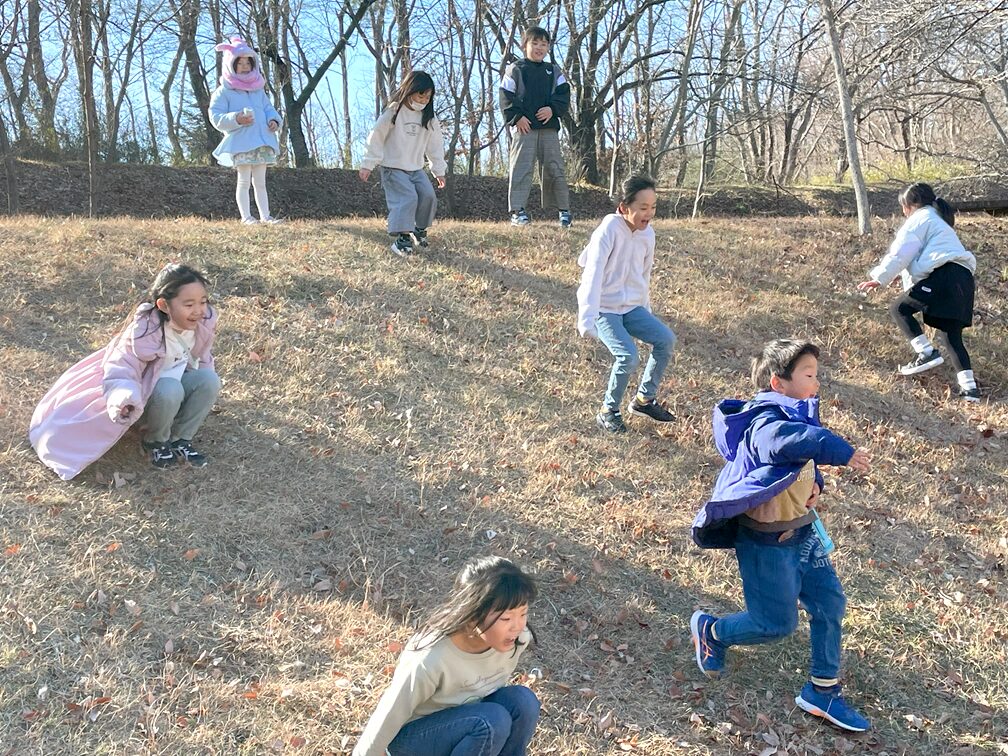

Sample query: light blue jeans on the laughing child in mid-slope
[595,307,675,412]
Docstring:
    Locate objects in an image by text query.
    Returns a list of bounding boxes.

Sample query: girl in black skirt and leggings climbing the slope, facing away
[858,183,980,402]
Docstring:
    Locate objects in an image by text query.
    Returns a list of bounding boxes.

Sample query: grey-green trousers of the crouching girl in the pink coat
[141,368,221,445]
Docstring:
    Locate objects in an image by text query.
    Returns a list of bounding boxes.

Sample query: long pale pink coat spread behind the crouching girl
[28,304,217,481]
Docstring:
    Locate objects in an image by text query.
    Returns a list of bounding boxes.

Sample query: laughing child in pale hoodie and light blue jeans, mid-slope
[578,175,675,433]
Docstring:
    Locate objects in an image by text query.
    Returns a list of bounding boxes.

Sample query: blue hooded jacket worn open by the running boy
[692,391,854,548]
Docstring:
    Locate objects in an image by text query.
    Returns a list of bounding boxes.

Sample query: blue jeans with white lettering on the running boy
[714,525,847,679]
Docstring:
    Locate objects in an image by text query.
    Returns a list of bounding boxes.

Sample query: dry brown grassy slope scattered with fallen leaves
[0,210,1008,756]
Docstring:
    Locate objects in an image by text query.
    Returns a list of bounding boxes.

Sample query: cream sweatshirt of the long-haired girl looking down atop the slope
[361,105,448,177]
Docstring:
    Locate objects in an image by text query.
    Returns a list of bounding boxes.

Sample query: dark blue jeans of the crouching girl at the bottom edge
[388,685,539,756]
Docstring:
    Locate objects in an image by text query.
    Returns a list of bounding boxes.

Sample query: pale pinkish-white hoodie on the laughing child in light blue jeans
[578,213,654,336]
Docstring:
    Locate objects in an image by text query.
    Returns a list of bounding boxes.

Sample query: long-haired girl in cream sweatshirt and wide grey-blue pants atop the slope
[360,71,448,257]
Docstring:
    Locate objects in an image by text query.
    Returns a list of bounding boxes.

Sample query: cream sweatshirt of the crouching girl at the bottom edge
[353,630,532,756]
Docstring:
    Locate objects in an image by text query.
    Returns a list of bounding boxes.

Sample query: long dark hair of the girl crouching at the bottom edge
[420,556,538,650]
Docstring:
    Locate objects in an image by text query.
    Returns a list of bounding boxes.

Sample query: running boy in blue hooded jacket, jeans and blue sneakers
[689,339,870,732]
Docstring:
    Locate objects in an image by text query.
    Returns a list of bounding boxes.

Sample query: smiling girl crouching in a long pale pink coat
[28,263,221,480]
